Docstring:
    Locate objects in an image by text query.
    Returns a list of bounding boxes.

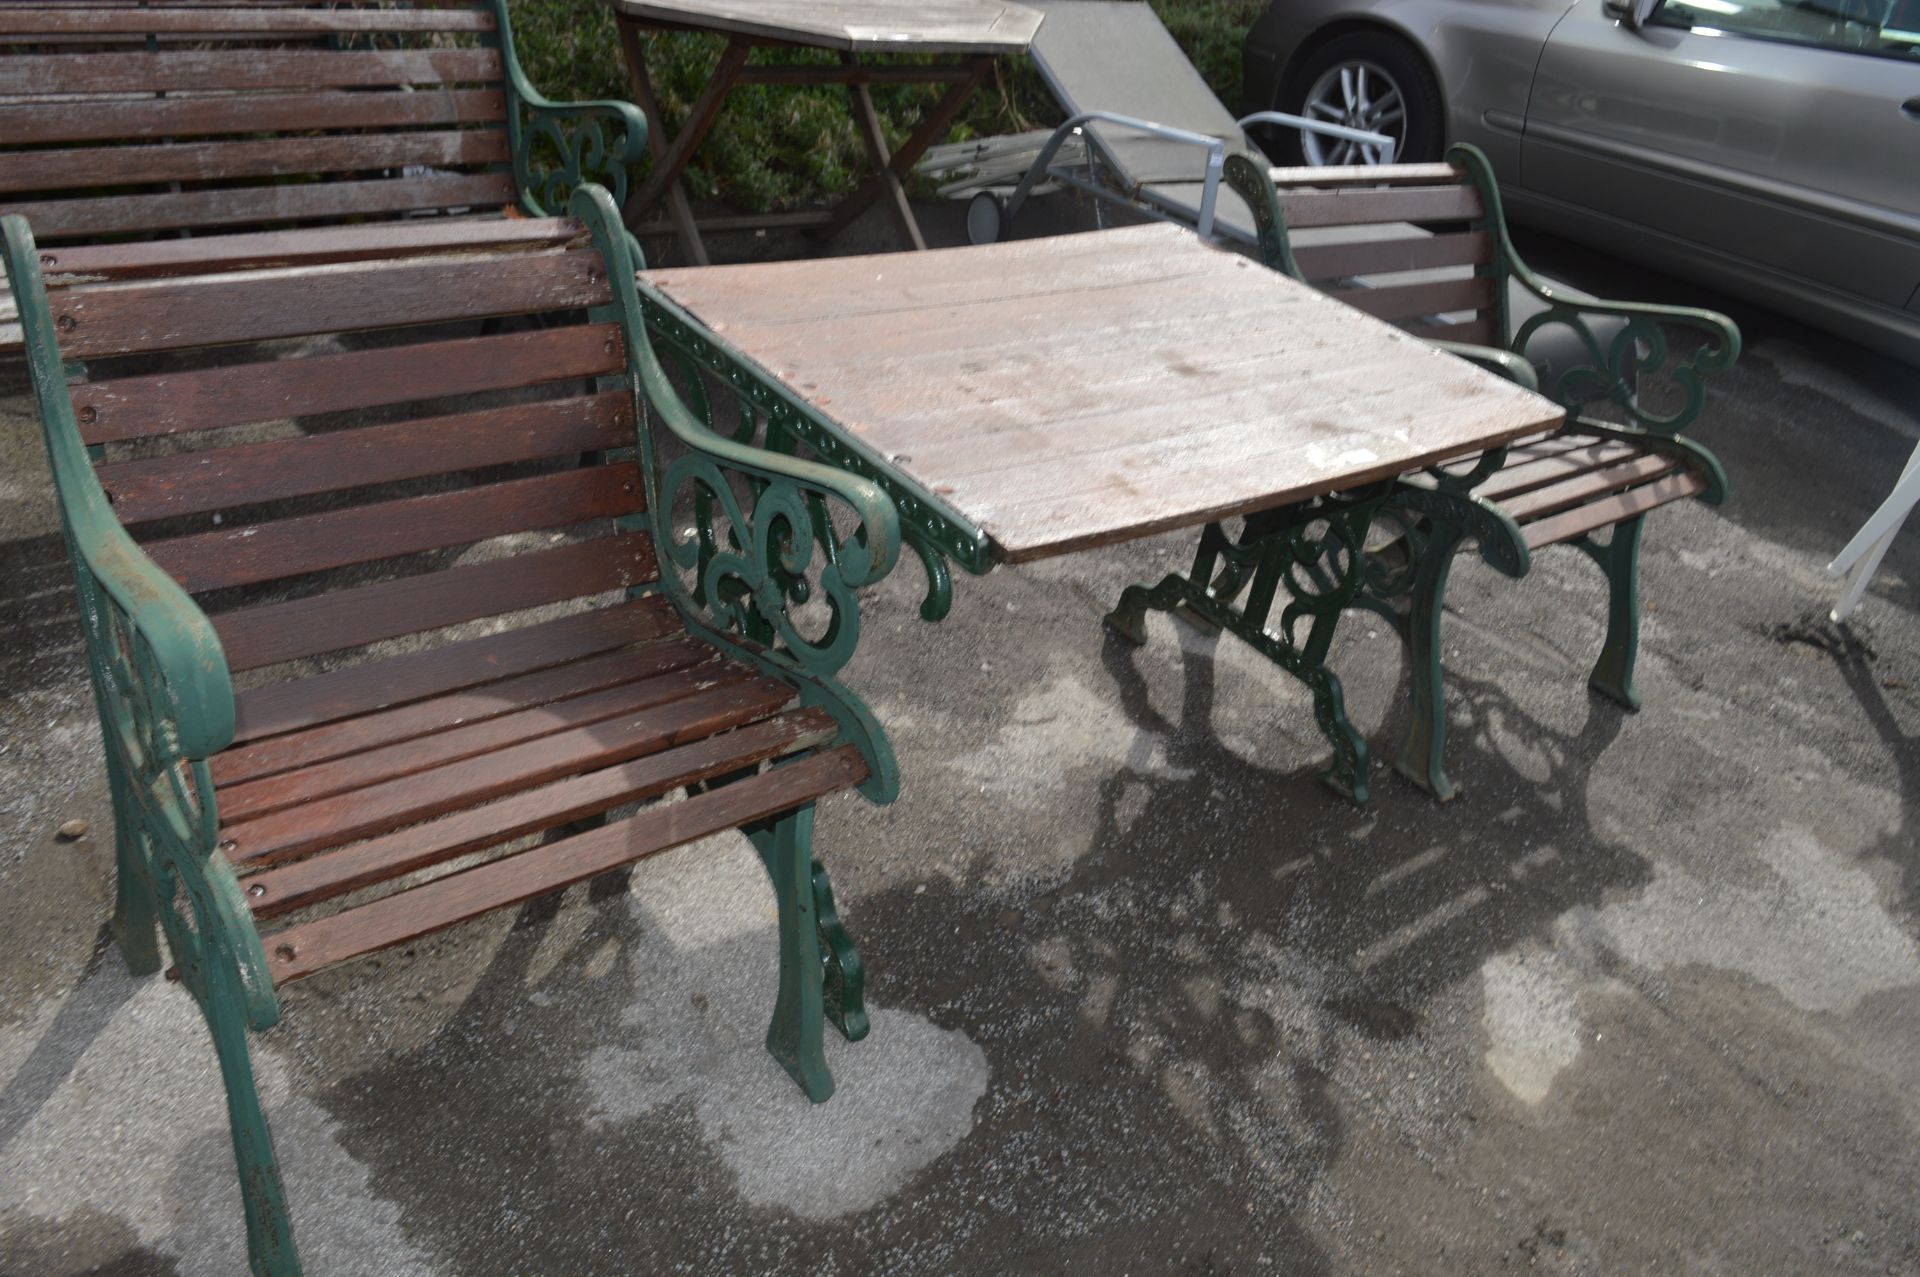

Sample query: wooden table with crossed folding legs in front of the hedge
[609,0,1041,265]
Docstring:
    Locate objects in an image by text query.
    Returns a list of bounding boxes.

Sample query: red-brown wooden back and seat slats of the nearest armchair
[35,234,866,960]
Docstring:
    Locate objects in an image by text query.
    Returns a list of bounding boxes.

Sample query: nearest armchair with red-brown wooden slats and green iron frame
[0,186,899,1273]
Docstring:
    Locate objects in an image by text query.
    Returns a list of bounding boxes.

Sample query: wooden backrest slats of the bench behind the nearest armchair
[0,0,516,244]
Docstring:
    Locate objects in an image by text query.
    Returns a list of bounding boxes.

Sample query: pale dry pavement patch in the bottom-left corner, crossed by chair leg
[0,971,434,1277]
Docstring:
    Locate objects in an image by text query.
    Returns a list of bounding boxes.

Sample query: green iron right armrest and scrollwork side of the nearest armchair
[570,184,900,803]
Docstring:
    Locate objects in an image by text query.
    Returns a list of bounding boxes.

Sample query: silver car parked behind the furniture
[1246,0,1920,363]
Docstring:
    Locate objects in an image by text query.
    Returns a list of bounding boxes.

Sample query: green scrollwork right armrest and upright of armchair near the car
[1448,142,1740,434]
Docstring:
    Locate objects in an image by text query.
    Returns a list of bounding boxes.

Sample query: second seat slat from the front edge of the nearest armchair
[246,709,837,918]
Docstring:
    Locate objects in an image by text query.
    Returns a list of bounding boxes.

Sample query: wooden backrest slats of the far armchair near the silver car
[1269,163,1501,346]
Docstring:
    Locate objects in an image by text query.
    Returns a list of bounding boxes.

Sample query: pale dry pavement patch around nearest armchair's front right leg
[582,835,987,1219]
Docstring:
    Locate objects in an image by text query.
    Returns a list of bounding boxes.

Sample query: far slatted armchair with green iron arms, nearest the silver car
[1225,146,1740,799]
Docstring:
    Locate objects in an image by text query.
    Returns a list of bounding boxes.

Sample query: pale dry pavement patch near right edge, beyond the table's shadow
[1480,828,1920,1104]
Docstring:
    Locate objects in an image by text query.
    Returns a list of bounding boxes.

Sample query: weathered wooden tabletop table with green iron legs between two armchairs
[639,225,1565,803]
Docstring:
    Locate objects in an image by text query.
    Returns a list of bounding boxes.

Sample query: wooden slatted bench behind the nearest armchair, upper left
[0,0,647,349]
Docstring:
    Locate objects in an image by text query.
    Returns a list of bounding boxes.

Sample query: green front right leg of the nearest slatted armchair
[753,805,833,1104]
